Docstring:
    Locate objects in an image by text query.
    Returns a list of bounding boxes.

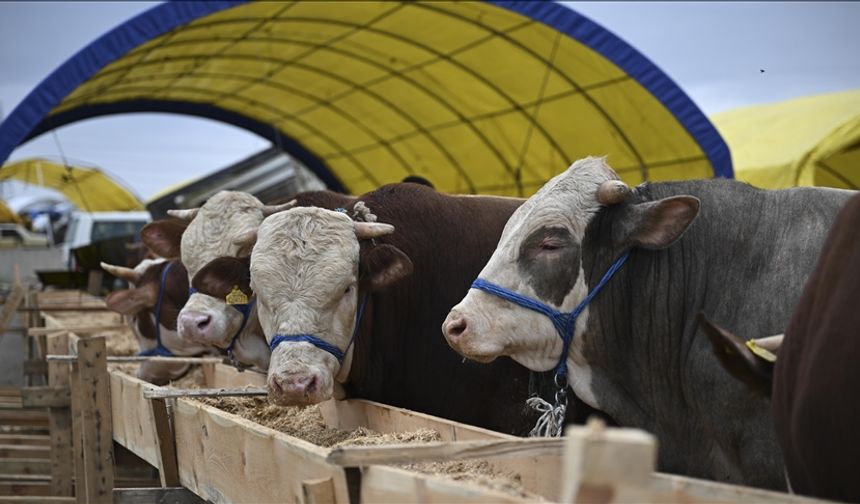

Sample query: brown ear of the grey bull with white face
[615,196,701,249]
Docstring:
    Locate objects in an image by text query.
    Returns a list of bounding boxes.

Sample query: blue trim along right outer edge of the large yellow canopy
[488,0,734,178]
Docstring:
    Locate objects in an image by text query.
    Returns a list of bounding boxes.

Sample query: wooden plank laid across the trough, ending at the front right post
[326,438,564,467]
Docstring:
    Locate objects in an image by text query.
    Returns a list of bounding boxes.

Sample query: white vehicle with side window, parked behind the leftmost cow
[63,212,152,269]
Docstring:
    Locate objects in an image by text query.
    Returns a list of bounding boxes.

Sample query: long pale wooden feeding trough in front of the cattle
[0,290,836,504]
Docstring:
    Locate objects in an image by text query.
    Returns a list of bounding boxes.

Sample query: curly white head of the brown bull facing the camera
[251,207,412,405]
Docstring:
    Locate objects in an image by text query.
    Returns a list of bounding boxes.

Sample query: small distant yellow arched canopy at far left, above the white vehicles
[0,159,144,212]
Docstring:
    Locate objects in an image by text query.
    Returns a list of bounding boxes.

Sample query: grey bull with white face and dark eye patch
[442,157,852,489]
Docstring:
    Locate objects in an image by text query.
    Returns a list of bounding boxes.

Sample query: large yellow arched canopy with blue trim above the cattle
[0,1,732,195]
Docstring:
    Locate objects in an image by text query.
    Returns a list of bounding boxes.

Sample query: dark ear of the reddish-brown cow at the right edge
[696,313,774,395]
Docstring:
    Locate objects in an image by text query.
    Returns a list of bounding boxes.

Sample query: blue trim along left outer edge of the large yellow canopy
[0,0,246,164]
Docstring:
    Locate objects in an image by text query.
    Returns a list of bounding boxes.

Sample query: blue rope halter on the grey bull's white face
[472,250,630,382]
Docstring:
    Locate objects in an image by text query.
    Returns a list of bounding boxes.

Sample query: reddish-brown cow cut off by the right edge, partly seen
[700,192,860,502]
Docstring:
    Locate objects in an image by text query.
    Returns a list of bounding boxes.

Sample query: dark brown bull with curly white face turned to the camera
[245,183,548,434]
